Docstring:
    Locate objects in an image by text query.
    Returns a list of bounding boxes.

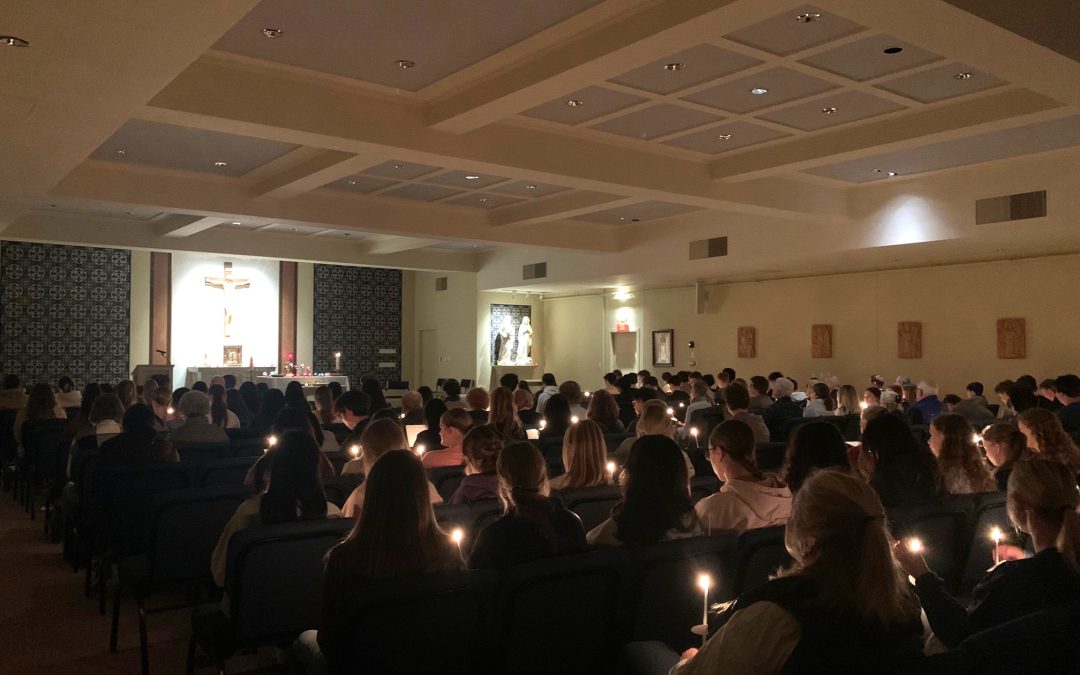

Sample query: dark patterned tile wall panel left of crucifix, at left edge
[0,242,131,386]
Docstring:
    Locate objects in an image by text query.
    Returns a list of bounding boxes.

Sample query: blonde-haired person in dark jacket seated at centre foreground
[469,443,588,569]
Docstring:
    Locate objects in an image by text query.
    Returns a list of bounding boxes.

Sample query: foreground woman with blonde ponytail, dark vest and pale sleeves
[672,468,922,675]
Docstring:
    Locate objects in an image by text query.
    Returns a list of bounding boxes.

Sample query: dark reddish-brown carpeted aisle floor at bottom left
[0,492,272,675]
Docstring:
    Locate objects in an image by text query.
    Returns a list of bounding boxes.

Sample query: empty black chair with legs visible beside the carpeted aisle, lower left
[109,487,251,674]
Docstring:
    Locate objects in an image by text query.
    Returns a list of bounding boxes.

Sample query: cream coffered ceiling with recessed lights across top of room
[0,0,1080,285]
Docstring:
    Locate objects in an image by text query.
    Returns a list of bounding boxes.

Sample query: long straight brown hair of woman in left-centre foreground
[332,450,462,579]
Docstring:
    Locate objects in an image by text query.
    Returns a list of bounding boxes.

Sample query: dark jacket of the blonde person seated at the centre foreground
[469,497,588,569]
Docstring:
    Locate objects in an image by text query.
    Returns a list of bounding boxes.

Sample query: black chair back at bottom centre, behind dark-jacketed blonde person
[490,548,630,675]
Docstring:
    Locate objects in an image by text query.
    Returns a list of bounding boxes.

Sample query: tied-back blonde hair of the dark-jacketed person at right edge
[1009,459,1080,575]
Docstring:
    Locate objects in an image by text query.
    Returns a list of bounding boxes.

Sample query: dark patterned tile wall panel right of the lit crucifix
[313,265,402,386]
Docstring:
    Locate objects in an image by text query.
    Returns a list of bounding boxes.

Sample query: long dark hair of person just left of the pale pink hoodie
[611,436,697,544]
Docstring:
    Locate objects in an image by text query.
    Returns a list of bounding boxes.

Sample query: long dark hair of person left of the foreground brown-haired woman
[259,431,326,525]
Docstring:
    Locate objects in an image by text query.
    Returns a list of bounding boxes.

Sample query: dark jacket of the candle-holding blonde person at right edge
[916,548,1080,648]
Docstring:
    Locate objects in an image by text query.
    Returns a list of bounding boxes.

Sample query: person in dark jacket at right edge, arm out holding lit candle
[896,459,1080,648]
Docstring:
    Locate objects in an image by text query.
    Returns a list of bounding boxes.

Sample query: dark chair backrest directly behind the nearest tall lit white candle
[627,535,739,652]
